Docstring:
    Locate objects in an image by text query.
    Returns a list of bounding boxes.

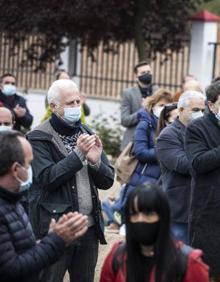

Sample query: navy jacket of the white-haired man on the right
[156,119,191,223]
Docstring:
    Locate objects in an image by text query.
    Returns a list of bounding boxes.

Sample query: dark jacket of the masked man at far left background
[0,91,33,130]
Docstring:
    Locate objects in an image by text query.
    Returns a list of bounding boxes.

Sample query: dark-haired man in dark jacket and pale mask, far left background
[0,73,33,132]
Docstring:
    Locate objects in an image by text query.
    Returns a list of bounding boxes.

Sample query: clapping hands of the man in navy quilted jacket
[49,212,88,245]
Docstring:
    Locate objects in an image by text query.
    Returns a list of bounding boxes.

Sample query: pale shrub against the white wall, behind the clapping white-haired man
[90,114,123,158]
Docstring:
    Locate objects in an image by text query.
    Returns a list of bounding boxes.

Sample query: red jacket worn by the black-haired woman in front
[100,243,209,282]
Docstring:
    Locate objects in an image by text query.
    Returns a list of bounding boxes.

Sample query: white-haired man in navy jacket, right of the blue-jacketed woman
[156,91,206,243]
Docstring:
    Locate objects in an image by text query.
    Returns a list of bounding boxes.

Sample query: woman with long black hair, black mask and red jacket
[100,183,209,282]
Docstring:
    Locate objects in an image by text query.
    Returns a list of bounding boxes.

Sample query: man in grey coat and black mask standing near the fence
[121,61,158,150]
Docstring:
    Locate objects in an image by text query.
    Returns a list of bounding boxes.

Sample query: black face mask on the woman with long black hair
[130,221,160,246]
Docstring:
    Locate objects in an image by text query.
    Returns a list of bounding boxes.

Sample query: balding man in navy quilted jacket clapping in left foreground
[0,131,88,282]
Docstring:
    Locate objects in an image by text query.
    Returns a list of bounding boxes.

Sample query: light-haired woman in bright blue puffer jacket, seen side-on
[122,89,172,210]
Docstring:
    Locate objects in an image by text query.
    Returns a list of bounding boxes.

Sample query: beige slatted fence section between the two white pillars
[74,41,190,100]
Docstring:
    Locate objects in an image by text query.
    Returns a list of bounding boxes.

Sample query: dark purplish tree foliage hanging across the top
[0,0,208,69]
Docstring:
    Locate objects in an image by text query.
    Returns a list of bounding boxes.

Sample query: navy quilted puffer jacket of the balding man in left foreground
[0,187,65,282]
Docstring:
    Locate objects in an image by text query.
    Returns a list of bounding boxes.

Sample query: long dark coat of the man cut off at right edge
[186,113,220,275]
